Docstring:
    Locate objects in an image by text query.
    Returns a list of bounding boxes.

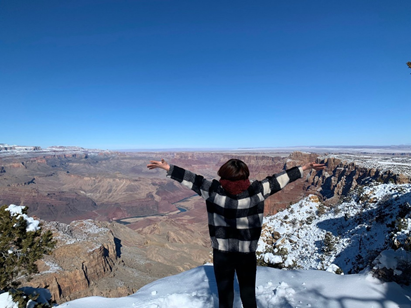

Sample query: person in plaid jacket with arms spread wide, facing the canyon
[147,159,325,308]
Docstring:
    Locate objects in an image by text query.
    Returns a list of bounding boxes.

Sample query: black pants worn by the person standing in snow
[213,249,257,308]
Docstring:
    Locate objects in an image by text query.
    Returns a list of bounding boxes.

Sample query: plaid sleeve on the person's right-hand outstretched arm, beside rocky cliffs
[261,167,303,198]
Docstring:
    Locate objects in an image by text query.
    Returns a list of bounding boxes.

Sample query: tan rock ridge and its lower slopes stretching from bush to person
[22,219,209,304]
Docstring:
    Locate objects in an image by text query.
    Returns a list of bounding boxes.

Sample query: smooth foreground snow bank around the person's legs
[21,265,411,308]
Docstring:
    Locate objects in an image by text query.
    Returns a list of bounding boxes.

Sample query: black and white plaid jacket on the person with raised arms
[167,165,303,253]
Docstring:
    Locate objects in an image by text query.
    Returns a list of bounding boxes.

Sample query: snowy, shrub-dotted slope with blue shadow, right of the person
[257,184,411,273]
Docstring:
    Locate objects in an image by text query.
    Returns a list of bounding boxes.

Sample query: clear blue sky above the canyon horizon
[0,0,411,149]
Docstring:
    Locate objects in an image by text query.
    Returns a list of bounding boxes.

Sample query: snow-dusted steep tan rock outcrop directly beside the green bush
[26,220,120,302]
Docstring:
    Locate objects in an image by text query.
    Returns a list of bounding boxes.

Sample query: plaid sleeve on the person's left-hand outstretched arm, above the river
[167,165,211,199]
